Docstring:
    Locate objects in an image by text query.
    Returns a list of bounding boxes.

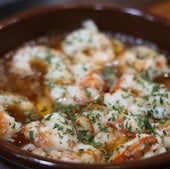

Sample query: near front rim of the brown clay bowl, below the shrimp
[0,140,170,169]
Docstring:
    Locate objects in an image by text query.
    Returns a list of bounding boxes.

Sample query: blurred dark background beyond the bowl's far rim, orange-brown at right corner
[0,0,170,19]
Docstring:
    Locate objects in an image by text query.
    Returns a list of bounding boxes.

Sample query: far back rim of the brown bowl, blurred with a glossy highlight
[0,2,170,31]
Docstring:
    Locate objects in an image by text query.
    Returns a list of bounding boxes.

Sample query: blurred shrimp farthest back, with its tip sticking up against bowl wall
[62,20,114,66]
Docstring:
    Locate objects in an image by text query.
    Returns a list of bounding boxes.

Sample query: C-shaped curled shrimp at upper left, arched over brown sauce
[10,45,72,83]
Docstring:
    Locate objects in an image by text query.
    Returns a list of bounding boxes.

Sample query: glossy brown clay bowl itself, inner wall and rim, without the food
[0,4,170,169]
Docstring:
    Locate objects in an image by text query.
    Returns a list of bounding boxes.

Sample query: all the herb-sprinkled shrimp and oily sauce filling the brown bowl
[0,20,170,164]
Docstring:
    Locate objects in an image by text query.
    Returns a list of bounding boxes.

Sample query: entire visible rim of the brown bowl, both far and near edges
[0,3,170,169]
